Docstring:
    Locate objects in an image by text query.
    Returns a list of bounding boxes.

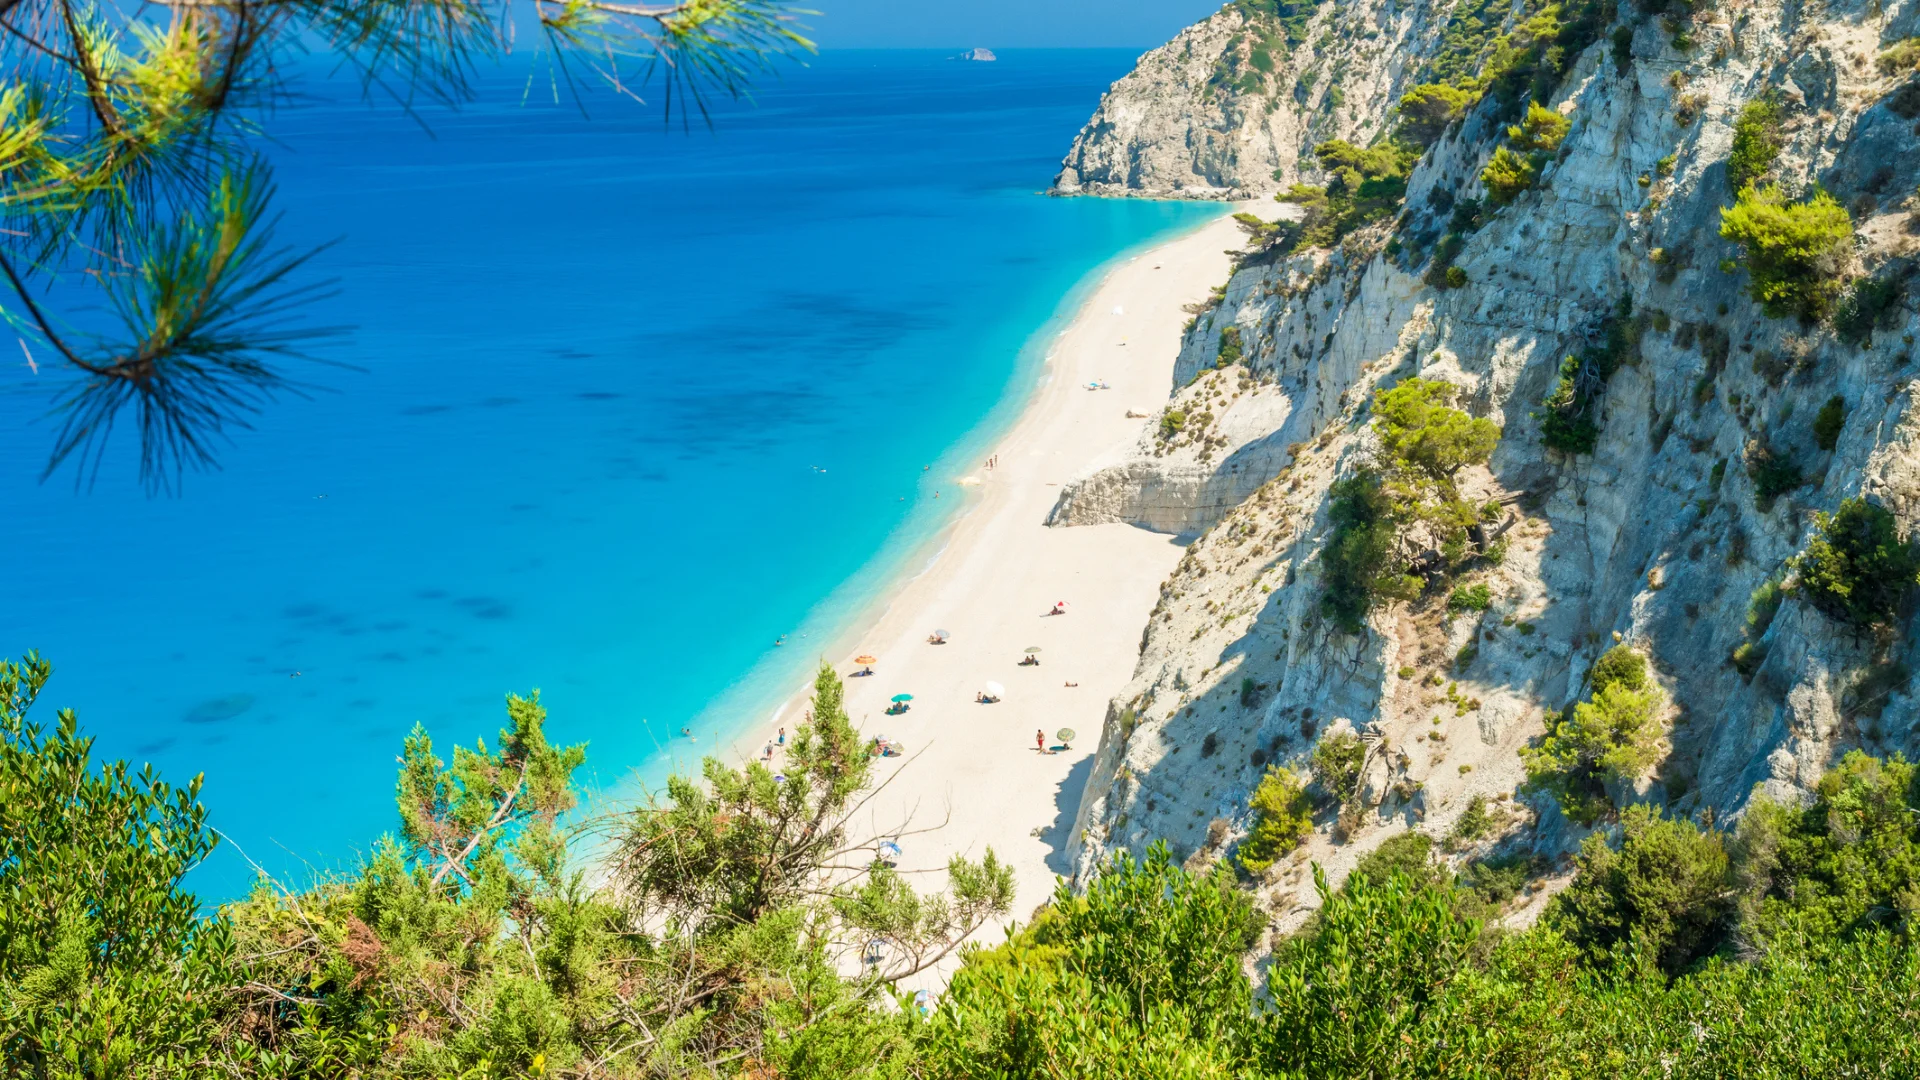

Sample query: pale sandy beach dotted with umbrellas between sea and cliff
[747,204,1273,990]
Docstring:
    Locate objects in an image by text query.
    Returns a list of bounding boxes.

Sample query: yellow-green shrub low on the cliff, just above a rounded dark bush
[1521,684,1665,824]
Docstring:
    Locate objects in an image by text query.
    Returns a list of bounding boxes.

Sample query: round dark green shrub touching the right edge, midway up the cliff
[1793,498,1920,626]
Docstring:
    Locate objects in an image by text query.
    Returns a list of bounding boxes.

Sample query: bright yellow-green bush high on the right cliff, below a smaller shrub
[1720,184,1853,319]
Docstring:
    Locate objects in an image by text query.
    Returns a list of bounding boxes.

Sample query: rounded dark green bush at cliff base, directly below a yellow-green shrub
[1542,805,1734,976]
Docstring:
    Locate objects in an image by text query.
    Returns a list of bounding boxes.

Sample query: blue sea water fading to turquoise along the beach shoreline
[0,50,1217,896]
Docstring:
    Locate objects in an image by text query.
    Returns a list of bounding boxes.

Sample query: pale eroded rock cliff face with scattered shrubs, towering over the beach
[1054,0,1920,926]
